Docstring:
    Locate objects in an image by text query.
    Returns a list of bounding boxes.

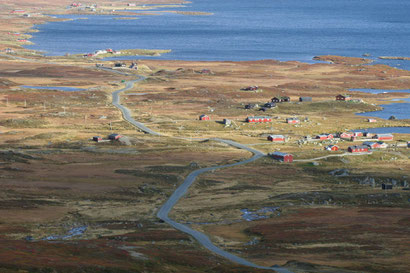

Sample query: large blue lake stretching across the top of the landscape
[27,0,410,69]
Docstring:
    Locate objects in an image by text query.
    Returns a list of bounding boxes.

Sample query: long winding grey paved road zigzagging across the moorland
[109,69,292,273]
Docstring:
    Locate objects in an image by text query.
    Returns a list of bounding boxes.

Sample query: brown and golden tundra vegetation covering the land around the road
[0,0,410,273]
